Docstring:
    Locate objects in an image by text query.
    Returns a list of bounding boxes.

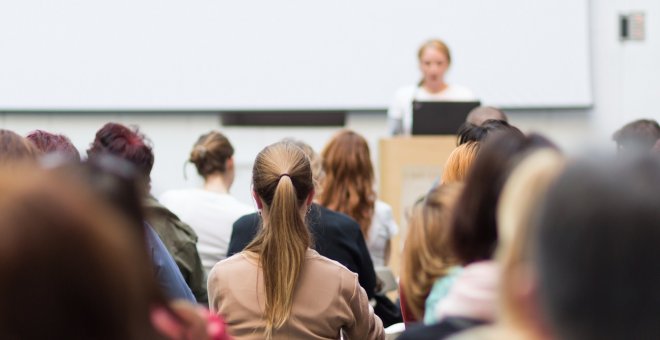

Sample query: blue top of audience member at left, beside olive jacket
[144,222,197,303]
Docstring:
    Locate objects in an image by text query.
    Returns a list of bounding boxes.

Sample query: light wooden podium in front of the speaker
[378,135,456,276]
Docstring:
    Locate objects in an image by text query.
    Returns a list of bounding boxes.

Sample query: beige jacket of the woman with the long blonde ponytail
[208,249,385,340]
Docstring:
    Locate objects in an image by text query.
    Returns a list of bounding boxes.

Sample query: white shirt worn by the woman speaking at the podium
[387,85,477,135]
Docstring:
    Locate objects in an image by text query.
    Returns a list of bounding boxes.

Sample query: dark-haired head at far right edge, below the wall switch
[612,119,660,154]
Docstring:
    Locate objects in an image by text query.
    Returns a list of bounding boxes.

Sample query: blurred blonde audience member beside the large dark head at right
[448,149,565,340]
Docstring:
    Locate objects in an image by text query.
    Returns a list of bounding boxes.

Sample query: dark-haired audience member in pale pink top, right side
[435,130,552,322]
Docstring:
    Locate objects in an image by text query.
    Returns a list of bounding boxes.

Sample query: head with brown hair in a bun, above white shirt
[189,131,234,185]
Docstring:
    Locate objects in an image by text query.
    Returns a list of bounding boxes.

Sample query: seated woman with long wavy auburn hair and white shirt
[319,130,398,266]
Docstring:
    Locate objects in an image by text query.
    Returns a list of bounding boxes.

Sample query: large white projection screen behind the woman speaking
[0,0,592,111]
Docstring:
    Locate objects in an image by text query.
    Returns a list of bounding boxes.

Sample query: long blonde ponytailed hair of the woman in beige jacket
[246,142,314,339]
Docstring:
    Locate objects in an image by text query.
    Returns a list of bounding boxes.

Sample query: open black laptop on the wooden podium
[411,101,481,135]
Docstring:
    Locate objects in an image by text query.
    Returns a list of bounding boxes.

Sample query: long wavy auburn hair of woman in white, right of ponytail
[319,130,376,237]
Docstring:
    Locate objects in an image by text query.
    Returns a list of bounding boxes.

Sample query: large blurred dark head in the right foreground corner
[531,155,660,340]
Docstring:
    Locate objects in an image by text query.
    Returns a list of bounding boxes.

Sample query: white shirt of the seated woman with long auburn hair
[366,201,399,267]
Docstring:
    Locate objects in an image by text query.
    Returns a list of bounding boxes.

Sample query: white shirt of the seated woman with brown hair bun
[159,189,255,275]
